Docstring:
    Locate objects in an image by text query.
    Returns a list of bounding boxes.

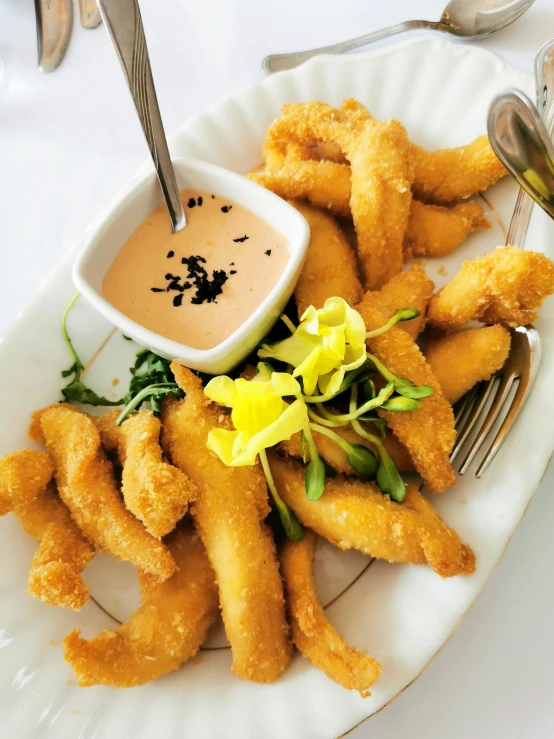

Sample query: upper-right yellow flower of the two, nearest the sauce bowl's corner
[258,298,366,395]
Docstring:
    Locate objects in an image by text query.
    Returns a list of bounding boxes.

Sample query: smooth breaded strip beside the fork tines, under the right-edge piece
[423,326,511,405]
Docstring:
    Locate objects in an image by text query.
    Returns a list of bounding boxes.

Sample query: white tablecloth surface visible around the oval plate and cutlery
[0,0,554,739]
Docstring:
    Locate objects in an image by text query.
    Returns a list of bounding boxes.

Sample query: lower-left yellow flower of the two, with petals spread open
[204,362,308,467]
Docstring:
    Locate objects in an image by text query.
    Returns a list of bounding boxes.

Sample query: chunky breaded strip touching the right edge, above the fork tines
[428,246,554,330]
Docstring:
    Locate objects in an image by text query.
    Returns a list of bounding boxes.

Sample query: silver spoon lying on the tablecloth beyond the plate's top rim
[262,0,535,74]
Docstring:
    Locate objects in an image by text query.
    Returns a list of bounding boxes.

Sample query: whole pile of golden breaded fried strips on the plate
[0,100,554,696]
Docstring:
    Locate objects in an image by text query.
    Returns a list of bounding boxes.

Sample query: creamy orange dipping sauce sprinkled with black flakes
[102,190,289,349]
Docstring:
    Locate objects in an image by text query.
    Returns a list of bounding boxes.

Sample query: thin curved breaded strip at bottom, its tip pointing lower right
[280,530,381,698]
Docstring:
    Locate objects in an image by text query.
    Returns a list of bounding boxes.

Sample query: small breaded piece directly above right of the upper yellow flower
[364,264,435,339]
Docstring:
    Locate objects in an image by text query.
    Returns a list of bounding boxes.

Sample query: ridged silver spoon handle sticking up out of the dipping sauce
[98,0,186,233]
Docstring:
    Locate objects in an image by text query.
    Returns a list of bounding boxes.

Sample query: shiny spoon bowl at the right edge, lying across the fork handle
[487,90,554,218]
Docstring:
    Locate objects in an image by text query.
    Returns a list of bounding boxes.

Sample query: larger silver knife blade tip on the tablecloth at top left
[35,0,73,72]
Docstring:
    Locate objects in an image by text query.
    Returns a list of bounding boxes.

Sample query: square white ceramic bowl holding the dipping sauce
[73,159,310,375]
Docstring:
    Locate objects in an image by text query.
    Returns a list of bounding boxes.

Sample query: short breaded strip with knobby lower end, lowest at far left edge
[15,484,94,611]
